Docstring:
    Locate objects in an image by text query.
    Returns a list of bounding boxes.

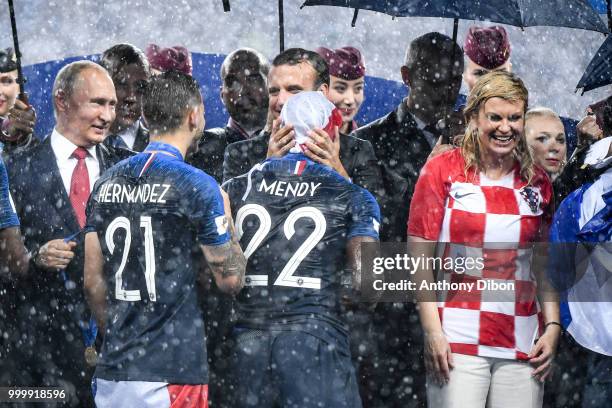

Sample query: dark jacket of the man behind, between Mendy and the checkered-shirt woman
[351,102,431,242]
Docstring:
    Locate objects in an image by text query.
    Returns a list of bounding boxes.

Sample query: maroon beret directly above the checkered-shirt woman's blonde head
[463,26,510,69]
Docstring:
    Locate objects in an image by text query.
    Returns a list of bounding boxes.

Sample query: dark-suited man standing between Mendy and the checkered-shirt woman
[353,33,463,406]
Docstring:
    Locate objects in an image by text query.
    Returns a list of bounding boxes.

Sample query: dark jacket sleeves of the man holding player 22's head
[223,131,382,196]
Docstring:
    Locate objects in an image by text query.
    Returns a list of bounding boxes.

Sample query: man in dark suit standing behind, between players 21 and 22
[188,48,270,183]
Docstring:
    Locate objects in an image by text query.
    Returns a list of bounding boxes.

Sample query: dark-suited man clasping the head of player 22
[223,48,381,195]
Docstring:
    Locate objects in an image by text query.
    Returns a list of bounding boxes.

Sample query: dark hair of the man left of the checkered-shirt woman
[404,32,463,74]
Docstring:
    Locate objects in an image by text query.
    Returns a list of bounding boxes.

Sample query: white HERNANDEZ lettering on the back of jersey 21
[98,183,170,204]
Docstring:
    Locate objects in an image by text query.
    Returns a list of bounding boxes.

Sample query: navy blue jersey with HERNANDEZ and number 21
[87,143,229,384]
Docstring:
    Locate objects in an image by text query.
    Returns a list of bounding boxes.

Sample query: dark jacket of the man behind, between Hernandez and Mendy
[187,126,251,184]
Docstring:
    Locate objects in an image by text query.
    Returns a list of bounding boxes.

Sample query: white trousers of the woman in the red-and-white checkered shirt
[427,353,544,408]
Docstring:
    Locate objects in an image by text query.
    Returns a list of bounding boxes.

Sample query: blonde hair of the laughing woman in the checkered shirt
[461,71,535,183]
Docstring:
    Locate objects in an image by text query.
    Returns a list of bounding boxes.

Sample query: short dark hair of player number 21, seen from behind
[142,70,202,134]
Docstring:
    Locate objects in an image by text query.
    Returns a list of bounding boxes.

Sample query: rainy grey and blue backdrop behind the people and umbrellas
[0,0,612,135]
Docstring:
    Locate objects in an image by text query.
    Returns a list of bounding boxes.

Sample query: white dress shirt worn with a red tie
[51,129,100,196]
